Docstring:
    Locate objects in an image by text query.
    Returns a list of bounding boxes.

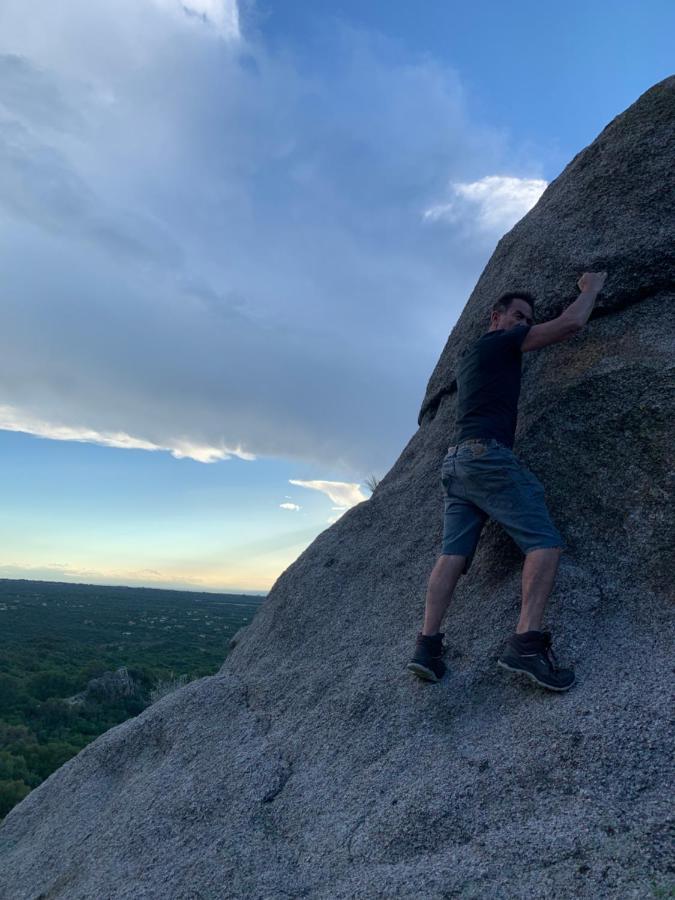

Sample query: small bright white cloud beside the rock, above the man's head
[423,175,547,235]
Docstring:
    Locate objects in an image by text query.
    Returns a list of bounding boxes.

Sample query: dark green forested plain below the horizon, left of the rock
[0,579,264,819]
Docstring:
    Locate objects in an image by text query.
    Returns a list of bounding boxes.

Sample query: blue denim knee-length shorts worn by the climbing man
[441,438,565,573]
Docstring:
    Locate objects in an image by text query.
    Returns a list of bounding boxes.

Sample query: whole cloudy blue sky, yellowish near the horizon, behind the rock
[0,0,675,593]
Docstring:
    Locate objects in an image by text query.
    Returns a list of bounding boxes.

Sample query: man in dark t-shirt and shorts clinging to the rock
[407,272,607,691]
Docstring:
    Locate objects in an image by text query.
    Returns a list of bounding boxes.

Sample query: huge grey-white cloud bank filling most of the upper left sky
[0,0,544,482]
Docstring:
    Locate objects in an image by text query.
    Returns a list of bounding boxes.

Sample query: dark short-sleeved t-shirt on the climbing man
[455,325,531,447]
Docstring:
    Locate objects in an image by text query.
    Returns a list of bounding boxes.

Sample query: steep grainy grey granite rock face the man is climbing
[0,77,675,900]
